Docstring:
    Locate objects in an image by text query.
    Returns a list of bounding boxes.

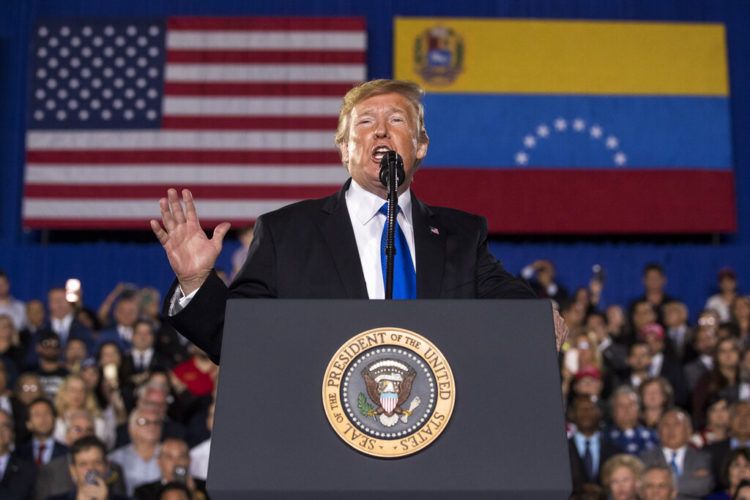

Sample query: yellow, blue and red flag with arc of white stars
[394,18,736,234]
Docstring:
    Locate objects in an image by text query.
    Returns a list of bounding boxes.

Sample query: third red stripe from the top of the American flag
[164,82,355,97]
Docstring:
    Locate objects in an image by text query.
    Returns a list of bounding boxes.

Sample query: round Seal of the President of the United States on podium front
[323,327,456,458]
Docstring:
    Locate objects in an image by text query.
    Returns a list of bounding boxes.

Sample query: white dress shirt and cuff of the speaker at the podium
[169,179,417,310]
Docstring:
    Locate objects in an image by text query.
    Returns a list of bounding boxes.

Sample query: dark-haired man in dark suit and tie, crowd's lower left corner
[16,398,68,467]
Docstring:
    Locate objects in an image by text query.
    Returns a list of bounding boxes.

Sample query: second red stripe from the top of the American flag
[167,49,367,64]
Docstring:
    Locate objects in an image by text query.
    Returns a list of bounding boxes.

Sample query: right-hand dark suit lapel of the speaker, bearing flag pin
[411,192,445,299]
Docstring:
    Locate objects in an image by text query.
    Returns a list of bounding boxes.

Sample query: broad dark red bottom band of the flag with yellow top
[414,168,737,234]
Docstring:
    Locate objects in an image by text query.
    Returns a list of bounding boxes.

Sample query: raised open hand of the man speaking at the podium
[150,189,230,295]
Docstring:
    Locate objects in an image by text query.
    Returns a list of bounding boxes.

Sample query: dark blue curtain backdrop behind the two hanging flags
[0,0,750,316]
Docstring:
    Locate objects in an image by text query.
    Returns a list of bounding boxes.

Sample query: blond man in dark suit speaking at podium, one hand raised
[151,80,564,362]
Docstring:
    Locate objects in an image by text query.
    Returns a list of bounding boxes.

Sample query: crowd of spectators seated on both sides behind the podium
[0,261,750,500]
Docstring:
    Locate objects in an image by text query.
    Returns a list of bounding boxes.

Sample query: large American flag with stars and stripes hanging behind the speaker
[23,17,367,229]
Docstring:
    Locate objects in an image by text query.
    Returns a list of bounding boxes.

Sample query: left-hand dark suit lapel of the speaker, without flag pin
[320,179,368,299]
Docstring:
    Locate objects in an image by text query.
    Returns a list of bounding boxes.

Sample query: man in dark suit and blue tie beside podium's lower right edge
[568,396,621,492]
